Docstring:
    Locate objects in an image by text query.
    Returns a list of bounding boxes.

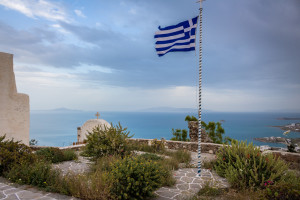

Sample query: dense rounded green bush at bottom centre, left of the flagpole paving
[110,156,171,199]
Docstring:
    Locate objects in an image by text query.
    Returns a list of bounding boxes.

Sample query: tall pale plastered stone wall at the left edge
[0,52,30,145]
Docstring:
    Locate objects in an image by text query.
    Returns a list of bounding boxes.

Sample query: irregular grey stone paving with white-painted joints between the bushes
[0,152,229,200]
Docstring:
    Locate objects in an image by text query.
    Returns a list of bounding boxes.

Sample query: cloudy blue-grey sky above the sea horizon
[0,0,300,112]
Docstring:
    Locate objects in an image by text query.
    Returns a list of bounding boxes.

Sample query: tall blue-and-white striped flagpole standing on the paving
[198,0,204,176]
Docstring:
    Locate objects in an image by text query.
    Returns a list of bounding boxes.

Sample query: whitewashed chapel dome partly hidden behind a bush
[77,119,111,143]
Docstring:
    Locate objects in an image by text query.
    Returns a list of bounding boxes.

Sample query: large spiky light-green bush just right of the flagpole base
[215,141,288,189]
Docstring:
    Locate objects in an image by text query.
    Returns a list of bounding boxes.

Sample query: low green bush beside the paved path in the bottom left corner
[4,161,59,188]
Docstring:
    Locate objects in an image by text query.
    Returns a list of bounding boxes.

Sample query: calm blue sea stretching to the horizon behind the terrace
[30,110,300,147]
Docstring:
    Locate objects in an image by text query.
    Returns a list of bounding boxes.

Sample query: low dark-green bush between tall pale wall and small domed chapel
[36,147,77,163]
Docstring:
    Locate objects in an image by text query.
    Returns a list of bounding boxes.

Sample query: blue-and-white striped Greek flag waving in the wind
[154,16,198,56]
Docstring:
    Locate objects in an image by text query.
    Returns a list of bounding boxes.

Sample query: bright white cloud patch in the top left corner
[0,0,69,22]
